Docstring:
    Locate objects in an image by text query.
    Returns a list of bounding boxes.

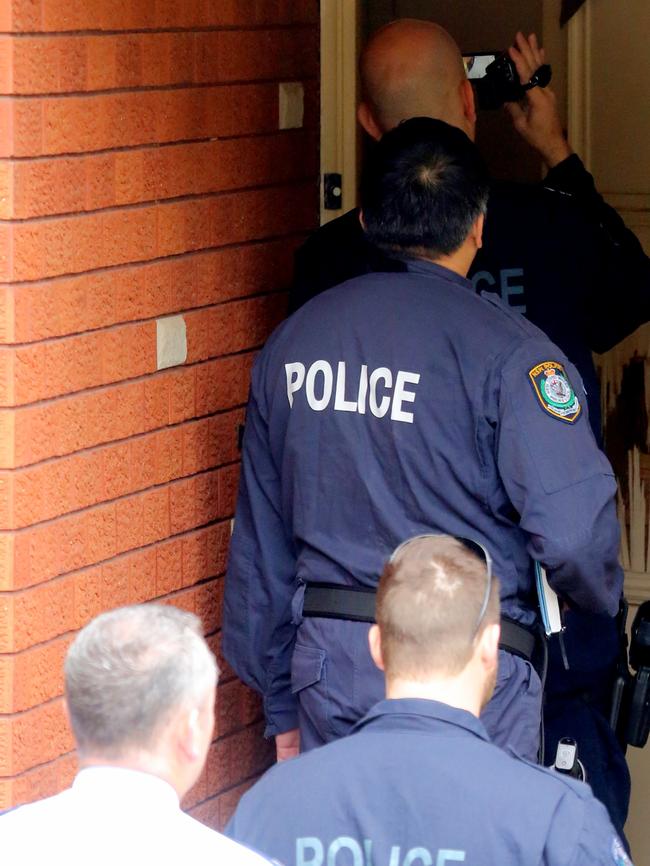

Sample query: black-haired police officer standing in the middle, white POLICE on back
[223,118,622,759]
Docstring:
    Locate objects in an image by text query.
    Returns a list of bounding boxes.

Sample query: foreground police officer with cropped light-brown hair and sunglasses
[226,532,630,866]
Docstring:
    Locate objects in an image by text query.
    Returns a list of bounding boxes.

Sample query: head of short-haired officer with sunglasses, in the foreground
[371,535,499,715]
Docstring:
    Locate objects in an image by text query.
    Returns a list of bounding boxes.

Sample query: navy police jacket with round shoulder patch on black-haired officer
[223,261,623,735]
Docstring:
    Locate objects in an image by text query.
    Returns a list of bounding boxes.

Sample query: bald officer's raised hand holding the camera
[506,33,572,168]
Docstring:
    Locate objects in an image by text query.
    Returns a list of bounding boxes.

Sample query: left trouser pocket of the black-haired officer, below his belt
[291,643,332,743]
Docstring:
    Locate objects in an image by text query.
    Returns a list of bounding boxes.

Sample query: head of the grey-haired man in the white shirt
[65,604,218,787]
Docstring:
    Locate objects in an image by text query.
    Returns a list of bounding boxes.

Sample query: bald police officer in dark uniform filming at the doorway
[290,20,650,832]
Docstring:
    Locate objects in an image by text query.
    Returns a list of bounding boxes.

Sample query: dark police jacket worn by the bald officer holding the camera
[289,154,650,441]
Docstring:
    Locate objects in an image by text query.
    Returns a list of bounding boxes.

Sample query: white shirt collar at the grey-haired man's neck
[72,767,180,813]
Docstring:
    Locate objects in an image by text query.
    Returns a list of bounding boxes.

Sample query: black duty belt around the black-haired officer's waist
[302,583,537,661]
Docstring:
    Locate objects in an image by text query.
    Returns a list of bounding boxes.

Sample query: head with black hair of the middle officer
[361,117,488,261]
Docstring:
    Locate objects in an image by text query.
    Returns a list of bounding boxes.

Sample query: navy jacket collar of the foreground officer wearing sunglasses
[353,698,490,742]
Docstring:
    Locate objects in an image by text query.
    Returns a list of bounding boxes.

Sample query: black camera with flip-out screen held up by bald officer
[463,52,551,109]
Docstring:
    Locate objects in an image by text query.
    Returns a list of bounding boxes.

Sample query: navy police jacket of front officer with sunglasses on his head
[226,699,630,866]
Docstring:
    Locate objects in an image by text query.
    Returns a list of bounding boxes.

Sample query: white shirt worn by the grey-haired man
[0,767,268,866]
